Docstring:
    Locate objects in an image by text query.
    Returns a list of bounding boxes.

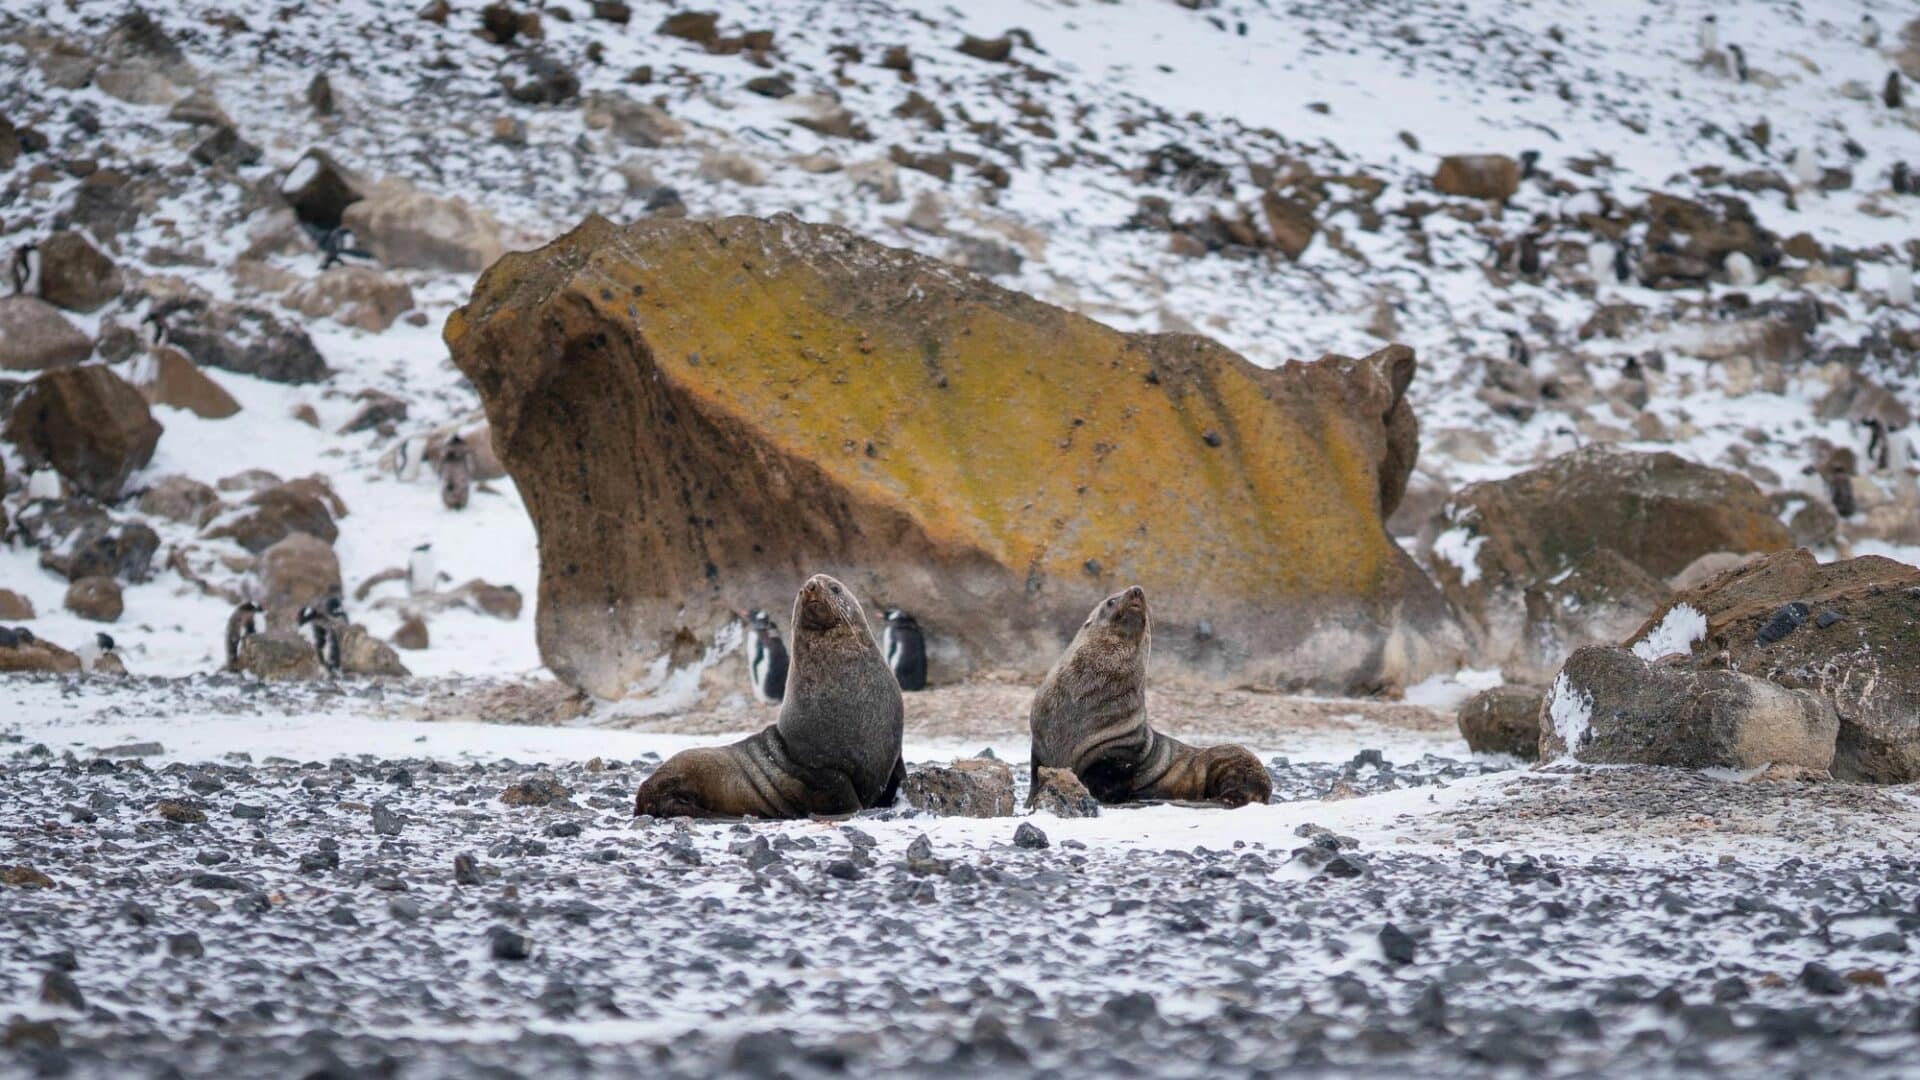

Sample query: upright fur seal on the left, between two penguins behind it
[634,575,906,819]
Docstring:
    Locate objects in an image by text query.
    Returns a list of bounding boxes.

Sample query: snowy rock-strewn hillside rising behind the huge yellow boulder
[0,0,1920,675]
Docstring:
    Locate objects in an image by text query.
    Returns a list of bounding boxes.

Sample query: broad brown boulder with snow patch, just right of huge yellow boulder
[1428,448,1789,684]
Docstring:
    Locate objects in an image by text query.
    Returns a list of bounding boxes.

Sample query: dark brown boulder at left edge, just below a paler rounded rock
[6,365,163,502]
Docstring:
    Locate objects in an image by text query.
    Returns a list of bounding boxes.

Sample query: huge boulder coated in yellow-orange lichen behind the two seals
[445,215,1461,696]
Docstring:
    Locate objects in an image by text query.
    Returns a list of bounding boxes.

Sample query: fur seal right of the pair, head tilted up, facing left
[1029,586,1273,807]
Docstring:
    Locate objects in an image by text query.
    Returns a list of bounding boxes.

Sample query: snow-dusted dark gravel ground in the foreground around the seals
[0,678,1920,1076]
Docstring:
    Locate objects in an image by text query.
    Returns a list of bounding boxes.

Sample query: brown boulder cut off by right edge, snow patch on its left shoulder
[1630,550,1920,784]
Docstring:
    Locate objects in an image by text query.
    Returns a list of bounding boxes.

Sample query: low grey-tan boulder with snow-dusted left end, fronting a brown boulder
[1540,646,1839,771]
